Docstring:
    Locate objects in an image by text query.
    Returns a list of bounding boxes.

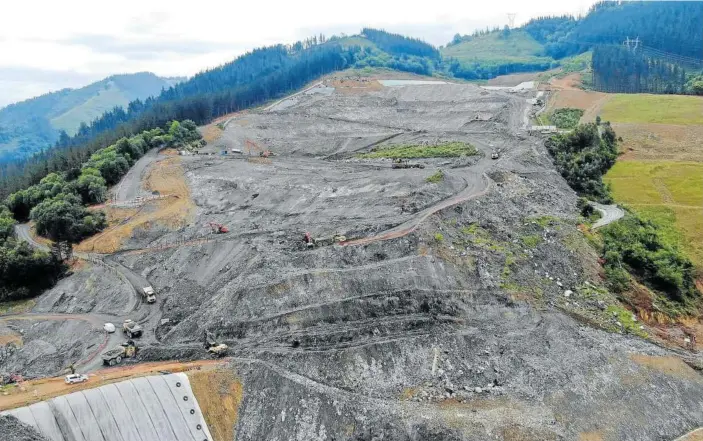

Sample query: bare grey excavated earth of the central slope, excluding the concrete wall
[1,79,703,441]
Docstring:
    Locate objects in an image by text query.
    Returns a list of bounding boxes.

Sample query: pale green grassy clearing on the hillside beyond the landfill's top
[442,30,552,64]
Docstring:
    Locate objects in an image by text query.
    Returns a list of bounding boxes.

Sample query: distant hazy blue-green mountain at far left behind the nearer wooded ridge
[0,72,182,163]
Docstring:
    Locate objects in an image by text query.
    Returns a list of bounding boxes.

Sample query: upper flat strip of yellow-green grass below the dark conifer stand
[600,94,703,125]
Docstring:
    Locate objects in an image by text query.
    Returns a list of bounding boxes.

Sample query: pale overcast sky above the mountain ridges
[0,0,594,107]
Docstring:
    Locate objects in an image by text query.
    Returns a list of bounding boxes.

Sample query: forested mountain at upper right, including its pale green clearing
[442,1,703,80]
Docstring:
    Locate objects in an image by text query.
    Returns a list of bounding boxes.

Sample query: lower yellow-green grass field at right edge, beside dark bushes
[604,161,703,269]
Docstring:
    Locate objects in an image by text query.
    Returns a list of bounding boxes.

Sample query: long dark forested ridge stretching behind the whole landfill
[5,2,703,196]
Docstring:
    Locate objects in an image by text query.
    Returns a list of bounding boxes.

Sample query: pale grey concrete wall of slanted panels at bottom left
[2,373,212,441]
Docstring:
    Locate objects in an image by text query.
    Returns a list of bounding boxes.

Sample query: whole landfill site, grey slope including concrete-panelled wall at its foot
[0,73,703,441]
